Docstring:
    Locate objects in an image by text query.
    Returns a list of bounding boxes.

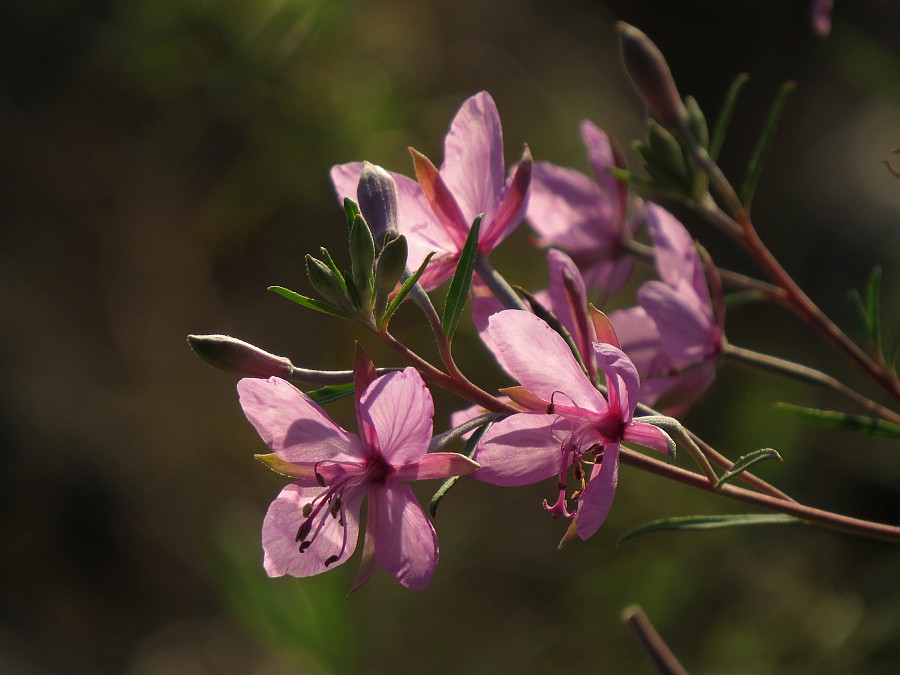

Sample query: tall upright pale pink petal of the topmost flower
[441,91,506,225]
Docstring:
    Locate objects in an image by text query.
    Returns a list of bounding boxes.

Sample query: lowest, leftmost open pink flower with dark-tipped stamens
[238,368,478,590]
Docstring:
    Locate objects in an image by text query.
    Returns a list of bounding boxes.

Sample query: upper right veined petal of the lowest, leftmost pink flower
[360,368,434,466]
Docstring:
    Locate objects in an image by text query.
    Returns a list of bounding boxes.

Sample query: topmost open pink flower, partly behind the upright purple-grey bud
[331,91,532,289]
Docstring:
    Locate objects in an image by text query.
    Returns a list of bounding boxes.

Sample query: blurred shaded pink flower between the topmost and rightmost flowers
[527,120,643,293]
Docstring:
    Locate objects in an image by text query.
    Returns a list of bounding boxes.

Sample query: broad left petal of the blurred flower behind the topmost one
[527,162,618,251]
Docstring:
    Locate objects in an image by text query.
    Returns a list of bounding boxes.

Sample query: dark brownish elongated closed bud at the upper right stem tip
[616,21,687,127]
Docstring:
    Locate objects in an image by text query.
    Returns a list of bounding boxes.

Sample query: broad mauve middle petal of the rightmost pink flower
[638,281,721,368]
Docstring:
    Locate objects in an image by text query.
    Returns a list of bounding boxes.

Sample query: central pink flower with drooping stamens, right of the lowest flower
[471,310,671,539]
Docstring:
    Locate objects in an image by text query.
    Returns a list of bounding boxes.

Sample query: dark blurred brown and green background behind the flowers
[0,0,900,675]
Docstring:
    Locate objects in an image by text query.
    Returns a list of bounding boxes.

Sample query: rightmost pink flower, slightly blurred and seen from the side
[609,204,724,415]
